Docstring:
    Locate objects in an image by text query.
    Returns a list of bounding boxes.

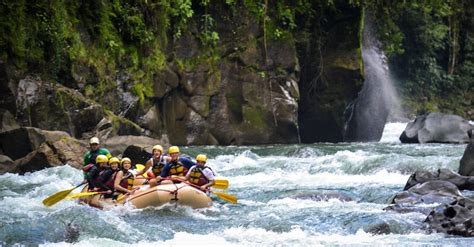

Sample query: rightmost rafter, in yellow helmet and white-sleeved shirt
[185,154,215,191]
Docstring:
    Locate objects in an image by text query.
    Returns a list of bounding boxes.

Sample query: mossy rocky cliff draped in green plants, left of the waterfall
[0,1,363,145]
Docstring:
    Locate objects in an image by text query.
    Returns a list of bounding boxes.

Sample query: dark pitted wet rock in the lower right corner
[425,198,474,237]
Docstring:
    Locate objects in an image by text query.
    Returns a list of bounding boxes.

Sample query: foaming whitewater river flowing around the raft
[0,123,472,246]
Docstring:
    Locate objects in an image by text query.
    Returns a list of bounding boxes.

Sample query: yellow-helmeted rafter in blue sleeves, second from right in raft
[160,146,194,179]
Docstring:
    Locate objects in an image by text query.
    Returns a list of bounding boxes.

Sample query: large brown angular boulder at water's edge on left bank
[0,127,86,173]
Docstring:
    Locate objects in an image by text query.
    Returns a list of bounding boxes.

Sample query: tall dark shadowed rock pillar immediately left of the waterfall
[297,2,364,143]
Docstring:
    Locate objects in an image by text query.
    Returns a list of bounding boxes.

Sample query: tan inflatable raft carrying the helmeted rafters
[80,183,212,208]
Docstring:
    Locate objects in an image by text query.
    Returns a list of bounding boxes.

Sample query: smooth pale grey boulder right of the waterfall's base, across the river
[400,112,473,143]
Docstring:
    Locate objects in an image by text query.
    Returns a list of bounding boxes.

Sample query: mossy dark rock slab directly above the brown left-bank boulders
[12,76,105,137]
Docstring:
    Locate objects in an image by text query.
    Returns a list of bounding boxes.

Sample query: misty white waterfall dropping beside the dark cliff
[344,15,402,142]
